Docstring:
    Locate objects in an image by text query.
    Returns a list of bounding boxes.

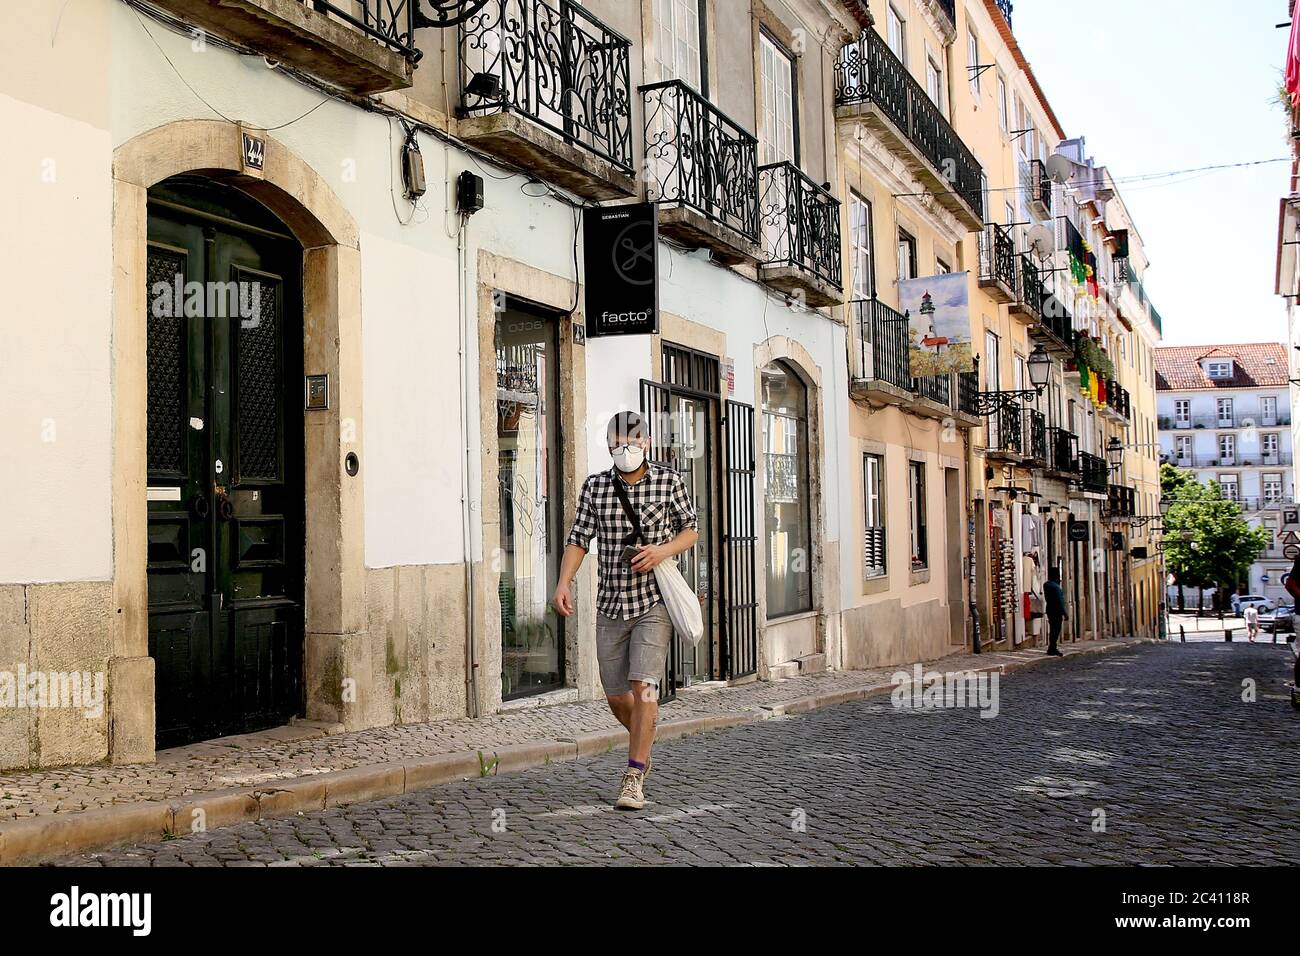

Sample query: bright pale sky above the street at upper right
[1011,0,1290,345]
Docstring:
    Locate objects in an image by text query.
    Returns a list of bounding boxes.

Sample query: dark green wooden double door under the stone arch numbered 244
[147,178,306,748]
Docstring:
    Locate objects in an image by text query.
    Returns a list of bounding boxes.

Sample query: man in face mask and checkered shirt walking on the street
[555,411,699,810]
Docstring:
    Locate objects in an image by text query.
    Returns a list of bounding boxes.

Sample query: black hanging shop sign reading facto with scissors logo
[582,203,659,338]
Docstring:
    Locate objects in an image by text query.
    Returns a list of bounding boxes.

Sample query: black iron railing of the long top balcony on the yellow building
[835,29,984,220]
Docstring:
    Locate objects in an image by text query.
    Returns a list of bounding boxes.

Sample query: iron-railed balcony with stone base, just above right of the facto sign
[641,79,763,265]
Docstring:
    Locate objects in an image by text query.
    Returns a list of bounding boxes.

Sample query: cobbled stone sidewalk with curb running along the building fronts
[0,640,1140,865]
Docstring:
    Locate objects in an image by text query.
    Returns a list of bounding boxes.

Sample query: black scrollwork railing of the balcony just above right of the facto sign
[641,79,758,243]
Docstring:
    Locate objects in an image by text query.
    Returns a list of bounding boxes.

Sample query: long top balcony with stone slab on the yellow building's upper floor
[835,30,984,232]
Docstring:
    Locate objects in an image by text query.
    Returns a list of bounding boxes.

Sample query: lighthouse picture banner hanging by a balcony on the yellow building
[898,272,975,378]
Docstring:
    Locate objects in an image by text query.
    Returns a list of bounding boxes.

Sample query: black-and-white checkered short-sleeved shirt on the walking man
[566,464,696,620]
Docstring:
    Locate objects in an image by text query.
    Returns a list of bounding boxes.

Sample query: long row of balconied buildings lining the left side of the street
[0,0,1158,769]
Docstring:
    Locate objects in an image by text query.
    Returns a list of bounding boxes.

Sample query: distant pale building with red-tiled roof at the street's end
[1156,342,1296,600]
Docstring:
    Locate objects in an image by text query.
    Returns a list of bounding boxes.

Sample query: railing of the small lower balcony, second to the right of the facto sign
[758,163,844,289]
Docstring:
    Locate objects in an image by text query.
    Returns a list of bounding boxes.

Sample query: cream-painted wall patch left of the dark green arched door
[0,93,112,583]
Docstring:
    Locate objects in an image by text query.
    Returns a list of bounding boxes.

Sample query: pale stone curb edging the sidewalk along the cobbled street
[0,639,1160,866]
